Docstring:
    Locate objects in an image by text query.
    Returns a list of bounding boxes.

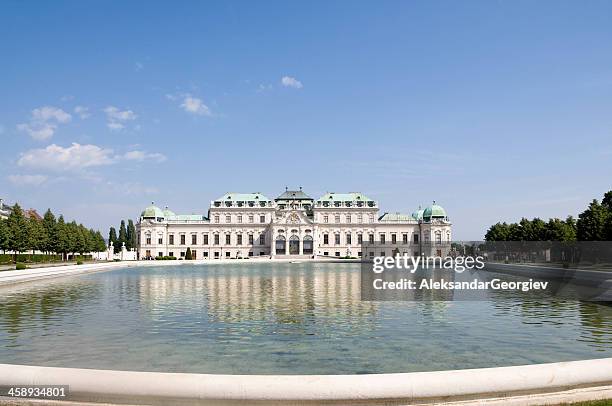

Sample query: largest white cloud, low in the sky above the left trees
[17,143,115,171]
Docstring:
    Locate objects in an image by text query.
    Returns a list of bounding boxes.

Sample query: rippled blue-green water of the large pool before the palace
[0,263,612,374]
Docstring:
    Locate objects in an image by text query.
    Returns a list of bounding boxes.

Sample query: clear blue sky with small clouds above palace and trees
[0,1,612,239]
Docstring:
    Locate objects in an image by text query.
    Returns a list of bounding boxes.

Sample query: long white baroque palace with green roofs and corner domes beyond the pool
[137,188,451,259]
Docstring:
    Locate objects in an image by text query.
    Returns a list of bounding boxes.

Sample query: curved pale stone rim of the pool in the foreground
[0,358,612,405]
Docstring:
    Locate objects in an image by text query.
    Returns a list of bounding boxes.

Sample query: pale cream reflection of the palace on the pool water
[138,264,378,323]
